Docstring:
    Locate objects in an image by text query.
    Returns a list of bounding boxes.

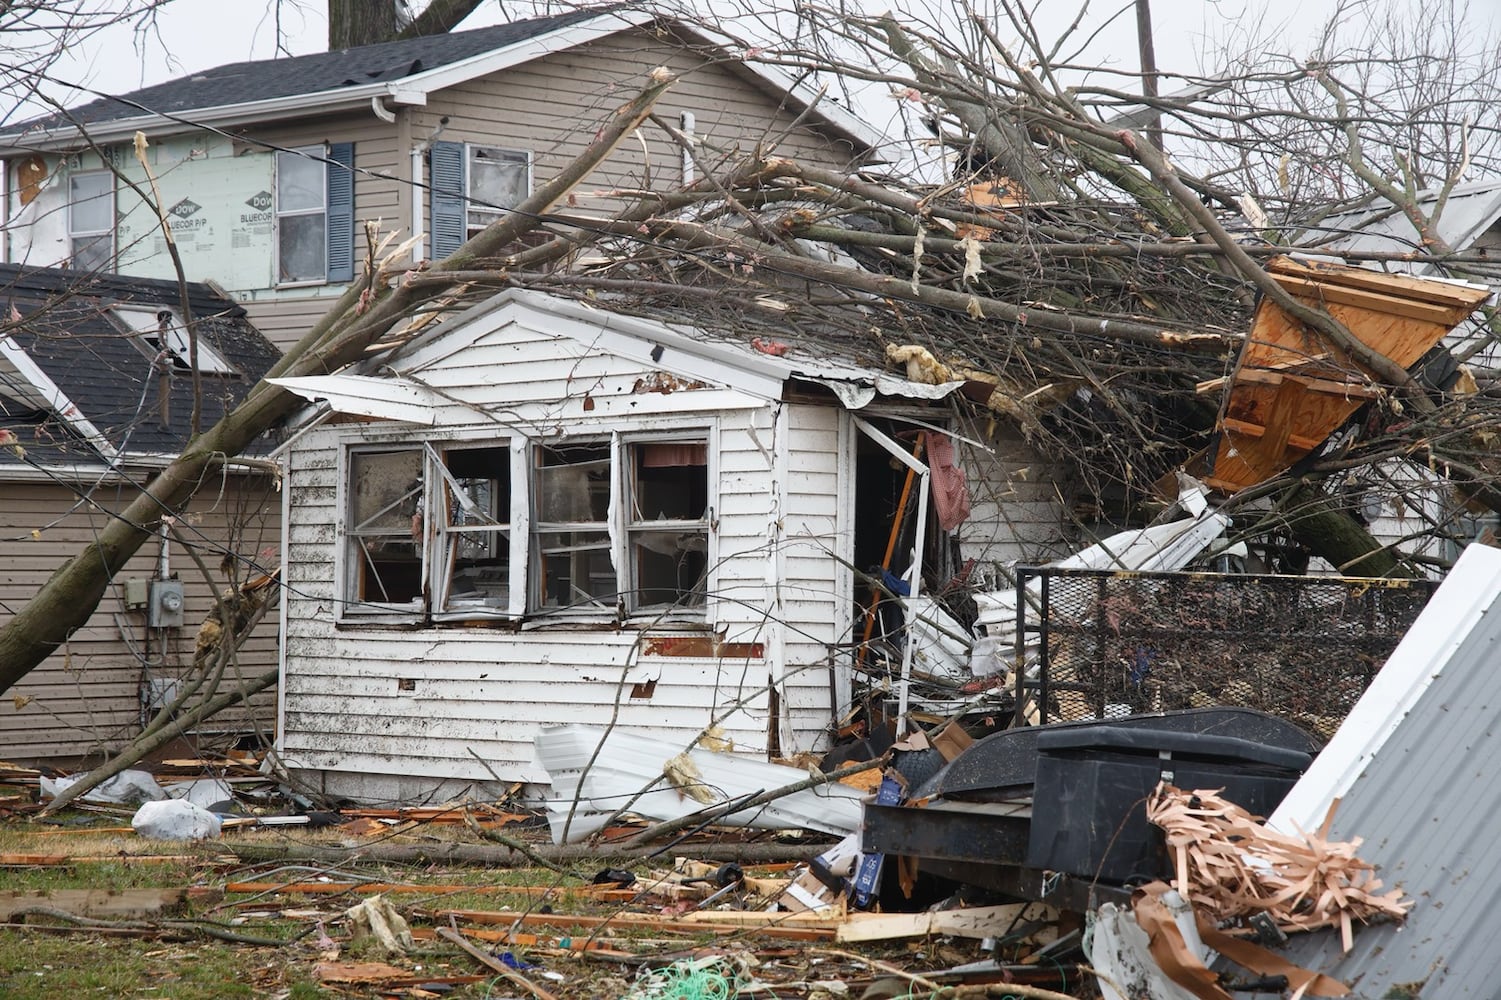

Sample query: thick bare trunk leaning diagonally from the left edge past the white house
[0,74,672,691]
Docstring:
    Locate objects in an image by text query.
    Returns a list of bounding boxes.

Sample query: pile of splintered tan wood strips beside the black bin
[1147,782,1412,952]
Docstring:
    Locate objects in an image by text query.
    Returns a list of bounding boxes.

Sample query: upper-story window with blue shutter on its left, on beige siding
[431,143,531,260]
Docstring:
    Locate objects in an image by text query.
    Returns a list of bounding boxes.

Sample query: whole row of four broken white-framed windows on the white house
[342,435,711,622]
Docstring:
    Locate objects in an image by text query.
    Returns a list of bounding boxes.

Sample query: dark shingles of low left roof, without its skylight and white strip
[0,264,281,464]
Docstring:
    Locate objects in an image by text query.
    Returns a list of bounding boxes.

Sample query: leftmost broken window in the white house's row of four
[345,447,423,611]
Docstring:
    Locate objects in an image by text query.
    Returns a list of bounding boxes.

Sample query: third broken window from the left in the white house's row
[531,441,620,611]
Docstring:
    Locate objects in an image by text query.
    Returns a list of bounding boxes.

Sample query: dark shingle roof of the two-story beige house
[0,8,605,137]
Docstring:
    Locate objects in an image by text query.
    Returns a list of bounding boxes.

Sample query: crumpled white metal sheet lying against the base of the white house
[536,725,863,844]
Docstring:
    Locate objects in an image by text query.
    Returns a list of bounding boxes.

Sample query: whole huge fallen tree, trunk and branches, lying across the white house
[0,5,1501,711]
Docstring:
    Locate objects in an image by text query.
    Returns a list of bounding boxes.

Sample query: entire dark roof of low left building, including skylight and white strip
[0,264,281,465]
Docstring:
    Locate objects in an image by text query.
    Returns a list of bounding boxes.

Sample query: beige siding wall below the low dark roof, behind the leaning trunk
[0,477,281,761]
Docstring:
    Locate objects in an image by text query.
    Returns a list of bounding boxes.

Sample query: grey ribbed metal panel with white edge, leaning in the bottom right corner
[1230,545,1501,1000]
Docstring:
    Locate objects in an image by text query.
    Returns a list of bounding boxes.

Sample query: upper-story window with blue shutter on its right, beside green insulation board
[275,143,354,285]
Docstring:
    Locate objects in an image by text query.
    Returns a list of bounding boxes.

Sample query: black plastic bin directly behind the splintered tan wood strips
[1027,725,1313,883]
